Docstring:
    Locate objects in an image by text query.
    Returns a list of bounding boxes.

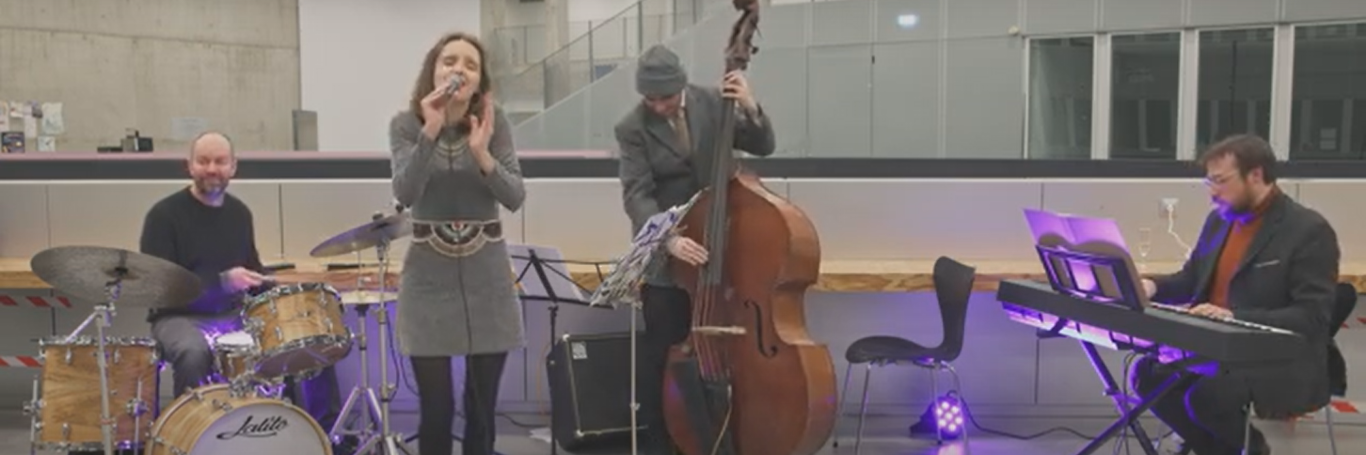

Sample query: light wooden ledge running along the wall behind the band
[0,258,1366,292]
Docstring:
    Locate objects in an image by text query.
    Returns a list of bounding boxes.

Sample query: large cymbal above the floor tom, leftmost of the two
[29,246,202,309]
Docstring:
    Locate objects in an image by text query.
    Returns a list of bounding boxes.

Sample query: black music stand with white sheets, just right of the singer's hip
[508,245,604,455]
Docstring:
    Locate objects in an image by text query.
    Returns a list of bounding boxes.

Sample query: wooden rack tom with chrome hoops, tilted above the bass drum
[242,283,351,378]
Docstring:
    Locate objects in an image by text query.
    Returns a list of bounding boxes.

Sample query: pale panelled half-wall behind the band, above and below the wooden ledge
[0,179,1366,414]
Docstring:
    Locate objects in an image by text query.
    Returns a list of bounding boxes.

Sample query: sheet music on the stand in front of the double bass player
[589,194,698,307]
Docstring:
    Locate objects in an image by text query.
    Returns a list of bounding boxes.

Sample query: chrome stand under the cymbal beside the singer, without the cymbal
[332,232,413,455]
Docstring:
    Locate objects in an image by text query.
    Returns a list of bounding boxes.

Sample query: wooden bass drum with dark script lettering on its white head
[146,384,332,455]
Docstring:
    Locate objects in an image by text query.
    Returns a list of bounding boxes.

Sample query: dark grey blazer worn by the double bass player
[616,85,775,235]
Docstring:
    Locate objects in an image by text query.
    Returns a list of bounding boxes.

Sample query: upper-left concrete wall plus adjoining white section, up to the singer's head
[0,0,479,153]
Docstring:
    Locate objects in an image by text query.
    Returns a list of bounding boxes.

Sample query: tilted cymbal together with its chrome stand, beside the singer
[309,212,413,455]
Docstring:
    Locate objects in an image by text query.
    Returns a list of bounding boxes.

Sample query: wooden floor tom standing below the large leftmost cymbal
[33,336,161,452]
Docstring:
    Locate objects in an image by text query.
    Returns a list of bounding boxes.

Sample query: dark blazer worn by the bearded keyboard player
[1153,193,1341,415]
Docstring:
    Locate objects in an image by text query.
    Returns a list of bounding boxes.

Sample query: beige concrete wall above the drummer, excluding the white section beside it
[0,0,299,152]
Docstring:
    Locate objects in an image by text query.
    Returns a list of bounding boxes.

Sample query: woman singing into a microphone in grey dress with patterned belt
[389,33,526,455]
